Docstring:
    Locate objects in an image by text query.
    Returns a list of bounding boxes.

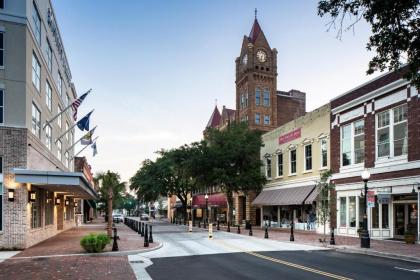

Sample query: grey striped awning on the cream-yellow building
[252,186,317,206]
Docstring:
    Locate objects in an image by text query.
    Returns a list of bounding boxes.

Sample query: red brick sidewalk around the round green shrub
[0,220,160,280]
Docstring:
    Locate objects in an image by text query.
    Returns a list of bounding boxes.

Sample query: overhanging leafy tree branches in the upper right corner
[318,0,420,89]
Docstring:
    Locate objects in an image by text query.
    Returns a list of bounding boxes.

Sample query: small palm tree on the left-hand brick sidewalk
[94,170,125,237]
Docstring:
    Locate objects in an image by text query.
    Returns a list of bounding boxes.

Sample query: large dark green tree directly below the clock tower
[193,123,266,223]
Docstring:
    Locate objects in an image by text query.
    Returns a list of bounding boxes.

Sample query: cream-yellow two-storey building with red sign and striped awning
[252,104,330,231]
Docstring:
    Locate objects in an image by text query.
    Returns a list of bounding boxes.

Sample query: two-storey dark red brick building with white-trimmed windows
[331,68,420,239]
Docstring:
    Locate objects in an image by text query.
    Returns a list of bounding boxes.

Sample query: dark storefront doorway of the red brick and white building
[394,202,418,239]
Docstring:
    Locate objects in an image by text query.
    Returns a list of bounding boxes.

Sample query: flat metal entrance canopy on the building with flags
[12,168,98,199]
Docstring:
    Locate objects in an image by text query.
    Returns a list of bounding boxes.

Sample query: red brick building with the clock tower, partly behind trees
[202,16,306,224]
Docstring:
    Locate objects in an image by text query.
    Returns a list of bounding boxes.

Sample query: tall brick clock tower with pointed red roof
[235,17,278,132]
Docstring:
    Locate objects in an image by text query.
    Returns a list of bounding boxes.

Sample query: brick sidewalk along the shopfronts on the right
[213,223,420,262]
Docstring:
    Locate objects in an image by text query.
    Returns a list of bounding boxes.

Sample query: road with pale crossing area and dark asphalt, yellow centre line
[134,224,420,280]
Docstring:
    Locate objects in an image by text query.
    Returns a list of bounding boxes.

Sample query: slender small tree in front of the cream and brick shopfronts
[316,170,335,241]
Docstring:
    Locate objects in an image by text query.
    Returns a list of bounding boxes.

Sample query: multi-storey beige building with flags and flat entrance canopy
[0,0,96,249]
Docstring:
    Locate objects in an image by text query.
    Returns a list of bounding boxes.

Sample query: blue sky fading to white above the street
[53,0,378,181]
